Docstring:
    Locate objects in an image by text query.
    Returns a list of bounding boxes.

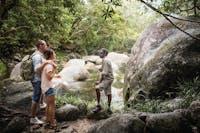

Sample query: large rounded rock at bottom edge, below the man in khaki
[88,114,145,133]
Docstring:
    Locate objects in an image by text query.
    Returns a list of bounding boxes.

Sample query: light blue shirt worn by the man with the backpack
[32,50,45,82]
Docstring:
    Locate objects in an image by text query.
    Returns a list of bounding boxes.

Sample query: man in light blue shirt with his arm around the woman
[30,40,48,124]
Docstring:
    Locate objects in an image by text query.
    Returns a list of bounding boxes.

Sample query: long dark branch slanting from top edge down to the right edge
[139,0,200,41]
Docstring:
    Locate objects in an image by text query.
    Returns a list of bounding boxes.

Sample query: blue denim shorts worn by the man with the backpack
[31,81,42,103]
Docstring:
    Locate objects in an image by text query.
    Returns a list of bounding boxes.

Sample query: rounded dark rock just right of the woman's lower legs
[56,104,80,121]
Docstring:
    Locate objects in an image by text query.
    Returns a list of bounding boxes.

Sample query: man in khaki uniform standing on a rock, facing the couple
[93,48,114,113]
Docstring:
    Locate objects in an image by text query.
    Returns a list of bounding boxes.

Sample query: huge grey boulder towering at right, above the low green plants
[124,18,200,102]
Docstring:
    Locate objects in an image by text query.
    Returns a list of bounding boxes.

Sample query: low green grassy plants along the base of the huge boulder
[131,78,200,113]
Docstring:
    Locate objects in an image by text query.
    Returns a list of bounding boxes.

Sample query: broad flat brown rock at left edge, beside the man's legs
[0,79,33,111]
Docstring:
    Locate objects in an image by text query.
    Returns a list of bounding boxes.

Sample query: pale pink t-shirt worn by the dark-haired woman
[41,64,54,94]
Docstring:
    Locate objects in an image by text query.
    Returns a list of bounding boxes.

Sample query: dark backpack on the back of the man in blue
[20,54,34,81]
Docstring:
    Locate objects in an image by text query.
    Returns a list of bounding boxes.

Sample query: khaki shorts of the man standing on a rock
[95,80,113,95]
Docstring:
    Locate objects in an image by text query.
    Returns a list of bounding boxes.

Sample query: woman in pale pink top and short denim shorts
[41,49,61,129]
